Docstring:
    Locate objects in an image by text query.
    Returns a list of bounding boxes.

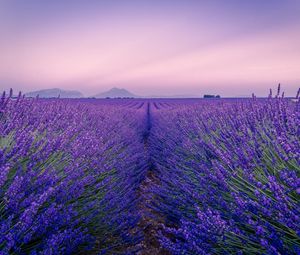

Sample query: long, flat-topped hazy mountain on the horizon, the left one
[25,88,83,98]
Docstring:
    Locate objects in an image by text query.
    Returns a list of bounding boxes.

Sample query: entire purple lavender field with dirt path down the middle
[0,88,300,255]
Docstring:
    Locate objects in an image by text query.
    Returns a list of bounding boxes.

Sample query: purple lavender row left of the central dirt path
[0,90,146,254]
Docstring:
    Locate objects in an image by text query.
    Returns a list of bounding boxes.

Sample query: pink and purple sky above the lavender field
[0,0,300,96]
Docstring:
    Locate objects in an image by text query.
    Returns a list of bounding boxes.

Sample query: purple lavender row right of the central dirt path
[150,89,300,254]
